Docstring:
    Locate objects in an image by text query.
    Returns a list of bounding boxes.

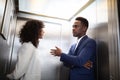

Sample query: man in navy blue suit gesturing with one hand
[51,17,96,80]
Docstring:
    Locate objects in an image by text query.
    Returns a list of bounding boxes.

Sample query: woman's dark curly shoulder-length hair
[19,20,44,47]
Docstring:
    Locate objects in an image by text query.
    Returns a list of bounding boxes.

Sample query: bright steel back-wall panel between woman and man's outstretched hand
[39,23,61,80]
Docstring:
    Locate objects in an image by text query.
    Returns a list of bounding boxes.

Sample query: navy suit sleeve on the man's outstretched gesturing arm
[60,40,96,67]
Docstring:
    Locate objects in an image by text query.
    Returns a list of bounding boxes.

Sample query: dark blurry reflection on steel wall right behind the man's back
[95,23,109,80]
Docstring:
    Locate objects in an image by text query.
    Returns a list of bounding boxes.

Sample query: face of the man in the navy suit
[72,20,86,38]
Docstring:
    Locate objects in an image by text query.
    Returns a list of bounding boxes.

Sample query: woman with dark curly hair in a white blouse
[7,20,44,80]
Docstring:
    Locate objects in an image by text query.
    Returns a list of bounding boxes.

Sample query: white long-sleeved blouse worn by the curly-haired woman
[7,42,41,80]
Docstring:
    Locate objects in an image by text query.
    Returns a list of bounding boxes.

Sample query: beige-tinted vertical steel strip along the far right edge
[108,0,120,80]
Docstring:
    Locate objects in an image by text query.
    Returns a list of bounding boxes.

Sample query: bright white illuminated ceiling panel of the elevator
[19,0,92,20]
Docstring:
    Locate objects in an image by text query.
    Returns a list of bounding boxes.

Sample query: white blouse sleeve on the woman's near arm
[7,45,33,79]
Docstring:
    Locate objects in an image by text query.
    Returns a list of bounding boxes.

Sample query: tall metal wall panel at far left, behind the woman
[0,0,16,80]
